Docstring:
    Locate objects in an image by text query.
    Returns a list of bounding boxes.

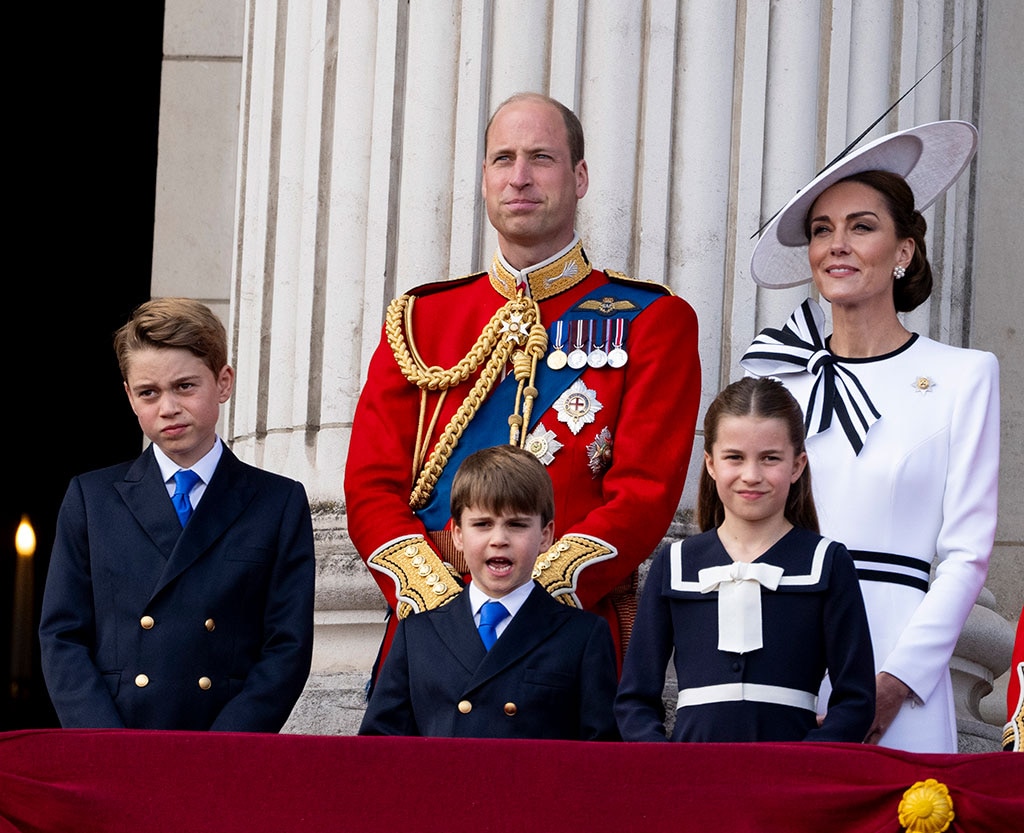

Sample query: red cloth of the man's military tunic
[345,248,700,667]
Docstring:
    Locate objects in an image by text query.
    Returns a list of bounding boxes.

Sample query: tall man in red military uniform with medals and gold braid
[345,93,700,677]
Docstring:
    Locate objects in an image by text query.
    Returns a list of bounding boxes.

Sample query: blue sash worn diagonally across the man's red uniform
[416,283,663,531]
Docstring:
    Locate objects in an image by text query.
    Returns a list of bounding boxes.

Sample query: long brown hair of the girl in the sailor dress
[697,376,819,532]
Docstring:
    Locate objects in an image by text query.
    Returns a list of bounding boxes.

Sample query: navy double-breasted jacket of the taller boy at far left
[39,447,315,732]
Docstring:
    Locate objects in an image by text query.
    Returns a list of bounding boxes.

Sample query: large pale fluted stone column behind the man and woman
[226,0,999,732]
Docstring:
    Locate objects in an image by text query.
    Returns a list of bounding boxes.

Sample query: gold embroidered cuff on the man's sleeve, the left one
[367,535,462,619]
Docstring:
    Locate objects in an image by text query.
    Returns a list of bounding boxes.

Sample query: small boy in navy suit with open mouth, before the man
[359,446,618,741]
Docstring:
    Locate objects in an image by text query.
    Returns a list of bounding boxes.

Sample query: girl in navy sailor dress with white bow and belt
[615,378,874,743]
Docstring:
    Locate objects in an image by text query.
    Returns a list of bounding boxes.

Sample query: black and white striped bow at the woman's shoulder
[739,298,882,454]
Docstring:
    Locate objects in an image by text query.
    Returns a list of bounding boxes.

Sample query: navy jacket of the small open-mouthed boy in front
[359,583,618,741]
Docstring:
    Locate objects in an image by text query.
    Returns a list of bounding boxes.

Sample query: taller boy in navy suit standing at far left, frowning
[39,298,315,732]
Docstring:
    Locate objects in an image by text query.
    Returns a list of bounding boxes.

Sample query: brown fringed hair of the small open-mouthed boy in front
[452,446,555,527]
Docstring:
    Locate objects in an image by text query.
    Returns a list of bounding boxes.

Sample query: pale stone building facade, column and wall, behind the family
[152,0,1024,748]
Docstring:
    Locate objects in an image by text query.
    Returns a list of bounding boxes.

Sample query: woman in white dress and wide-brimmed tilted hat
[741,121,999,752]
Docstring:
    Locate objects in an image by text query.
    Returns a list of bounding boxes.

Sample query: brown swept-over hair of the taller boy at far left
[114,298,227,381]
